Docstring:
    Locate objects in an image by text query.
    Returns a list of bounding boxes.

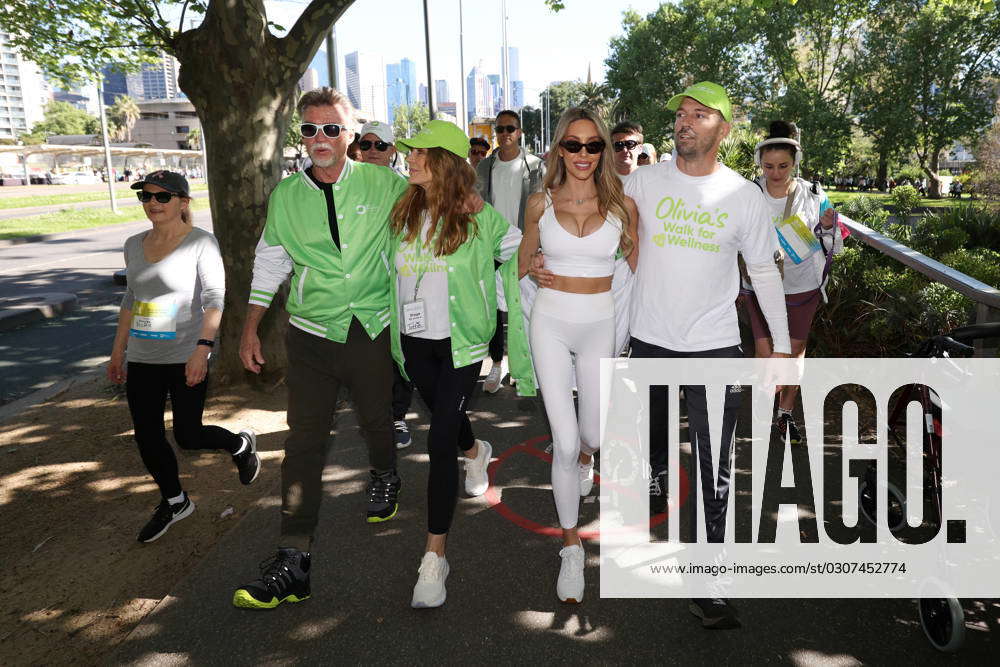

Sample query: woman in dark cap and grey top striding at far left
[107,171,260,542]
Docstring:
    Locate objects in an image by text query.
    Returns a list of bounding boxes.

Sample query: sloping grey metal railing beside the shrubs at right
[840,214,1000,357]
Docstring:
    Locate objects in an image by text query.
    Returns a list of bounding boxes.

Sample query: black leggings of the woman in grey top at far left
[125,361,243,498]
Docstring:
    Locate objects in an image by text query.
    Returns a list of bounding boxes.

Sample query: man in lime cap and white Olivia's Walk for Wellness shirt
[625,82,791,628]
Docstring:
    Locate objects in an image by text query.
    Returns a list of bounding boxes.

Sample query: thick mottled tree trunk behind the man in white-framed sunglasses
[178,40,301,384]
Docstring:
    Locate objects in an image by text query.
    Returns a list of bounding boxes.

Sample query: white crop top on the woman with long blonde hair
[538,196,621,278]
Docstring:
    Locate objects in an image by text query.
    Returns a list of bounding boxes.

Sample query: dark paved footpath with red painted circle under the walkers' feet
[109,384,998,665]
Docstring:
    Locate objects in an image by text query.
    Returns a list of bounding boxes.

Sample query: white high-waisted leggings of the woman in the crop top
[529,289,615,529]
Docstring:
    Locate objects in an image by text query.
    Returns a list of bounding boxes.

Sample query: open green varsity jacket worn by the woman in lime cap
[389,204,536,396]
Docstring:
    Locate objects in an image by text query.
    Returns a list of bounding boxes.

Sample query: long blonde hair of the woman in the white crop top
[544,107,635,257]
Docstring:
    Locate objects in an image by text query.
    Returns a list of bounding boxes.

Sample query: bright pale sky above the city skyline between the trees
[267,0,661,104]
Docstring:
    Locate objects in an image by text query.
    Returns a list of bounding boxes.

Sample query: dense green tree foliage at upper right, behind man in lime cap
[607,0,1000,180]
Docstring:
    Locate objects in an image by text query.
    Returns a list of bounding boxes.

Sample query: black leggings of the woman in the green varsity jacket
[402,336,480,535]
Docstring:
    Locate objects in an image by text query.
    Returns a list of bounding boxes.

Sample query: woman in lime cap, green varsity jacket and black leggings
[390,120,535,608]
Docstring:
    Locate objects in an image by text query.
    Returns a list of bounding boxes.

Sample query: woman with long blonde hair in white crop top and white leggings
[518,108,639,602]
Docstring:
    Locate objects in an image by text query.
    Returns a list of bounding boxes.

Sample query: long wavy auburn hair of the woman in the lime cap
[390,148,478,257]
